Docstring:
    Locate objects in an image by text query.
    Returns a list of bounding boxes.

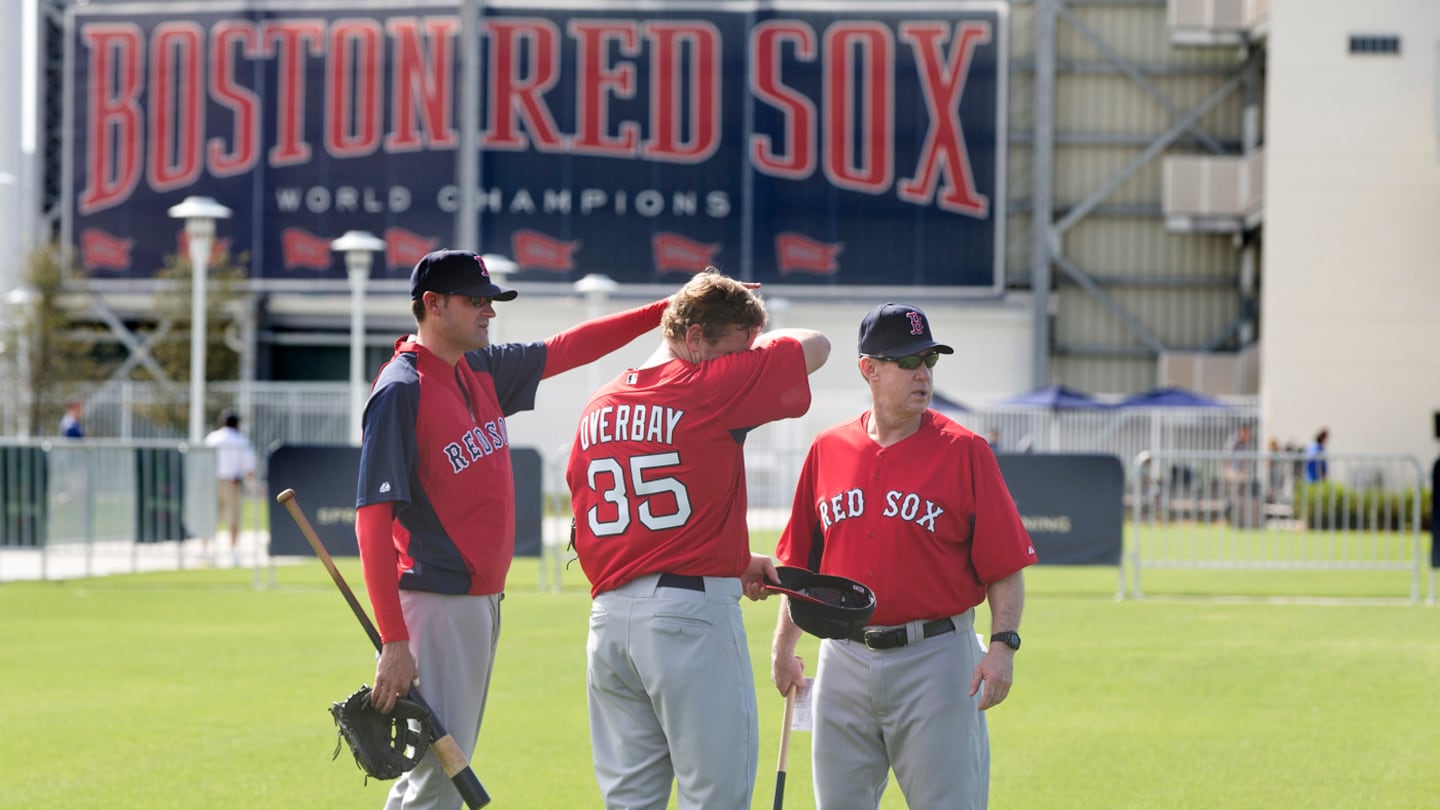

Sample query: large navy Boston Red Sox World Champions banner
[65,0,1008,289]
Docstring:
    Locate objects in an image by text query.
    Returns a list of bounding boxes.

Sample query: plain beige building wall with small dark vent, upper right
[1260,0,1440,461]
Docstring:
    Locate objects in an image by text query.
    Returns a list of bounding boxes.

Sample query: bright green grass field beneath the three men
[0,543,1440,810]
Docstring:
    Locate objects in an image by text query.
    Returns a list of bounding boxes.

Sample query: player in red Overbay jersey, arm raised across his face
[566,271,829,810]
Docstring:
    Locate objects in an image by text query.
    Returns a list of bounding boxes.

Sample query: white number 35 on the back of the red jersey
[585,451,691,538]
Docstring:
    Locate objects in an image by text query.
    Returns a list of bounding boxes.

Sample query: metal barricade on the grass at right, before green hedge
[1119,451,1434,601]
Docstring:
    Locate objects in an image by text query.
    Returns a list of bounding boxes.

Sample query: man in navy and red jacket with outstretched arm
[356,251,665,809]
